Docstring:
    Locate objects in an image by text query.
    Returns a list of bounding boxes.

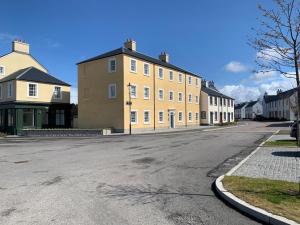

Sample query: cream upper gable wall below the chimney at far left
[0,52,47,79]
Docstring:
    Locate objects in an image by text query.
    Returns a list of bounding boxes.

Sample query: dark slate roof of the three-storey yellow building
[77,47,200,77]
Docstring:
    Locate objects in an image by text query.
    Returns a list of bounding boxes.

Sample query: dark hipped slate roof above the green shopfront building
[0,67,71,86]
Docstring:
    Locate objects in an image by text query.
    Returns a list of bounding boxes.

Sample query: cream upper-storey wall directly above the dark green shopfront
[16,80,71,103]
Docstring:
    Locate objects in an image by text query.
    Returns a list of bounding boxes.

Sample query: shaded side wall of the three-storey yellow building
[78,55,124,129]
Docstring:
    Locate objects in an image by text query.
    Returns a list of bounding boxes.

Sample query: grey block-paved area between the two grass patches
[232,135,300,182]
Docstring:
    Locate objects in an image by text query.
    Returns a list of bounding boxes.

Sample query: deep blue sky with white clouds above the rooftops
[0,0,293,103]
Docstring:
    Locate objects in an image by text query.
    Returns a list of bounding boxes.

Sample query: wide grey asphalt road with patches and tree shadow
[0,122,288,225]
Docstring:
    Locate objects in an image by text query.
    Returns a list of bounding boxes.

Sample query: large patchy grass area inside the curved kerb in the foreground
[223,176,300,223]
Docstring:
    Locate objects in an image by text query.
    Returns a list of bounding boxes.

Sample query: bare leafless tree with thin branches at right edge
[250,0,300,142]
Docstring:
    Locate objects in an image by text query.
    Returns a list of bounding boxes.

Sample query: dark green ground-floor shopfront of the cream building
[0,103,71,135]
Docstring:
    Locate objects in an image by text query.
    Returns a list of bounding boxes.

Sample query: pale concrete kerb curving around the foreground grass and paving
[215,130,299,225]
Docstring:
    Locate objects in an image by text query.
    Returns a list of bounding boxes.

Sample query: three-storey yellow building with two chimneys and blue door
[77,40,201,132]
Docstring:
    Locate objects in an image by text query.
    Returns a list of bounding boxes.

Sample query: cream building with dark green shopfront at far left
[0,40,70,134]
